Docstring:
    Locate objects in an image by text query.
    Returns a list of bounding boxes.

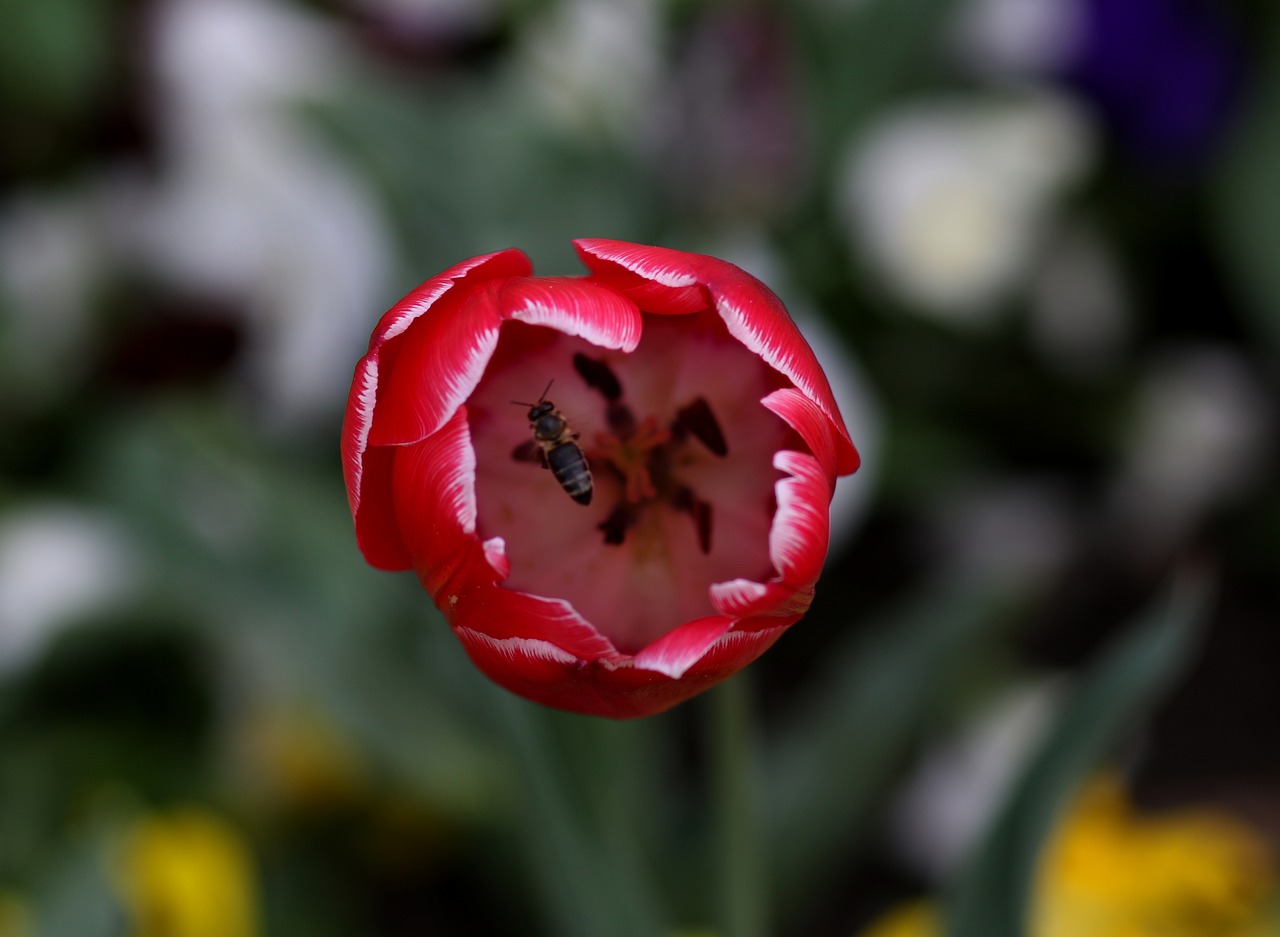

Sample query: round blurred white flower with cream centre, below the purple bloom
[840,92,1093,321]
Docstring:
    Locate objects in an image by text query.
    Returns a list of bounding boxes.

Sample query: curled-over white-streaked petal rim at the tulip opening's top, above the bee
[499,276,640,352]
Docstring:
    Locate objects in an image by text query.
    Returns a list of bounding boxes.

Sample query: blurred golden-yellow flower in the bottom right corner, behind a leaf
[863,776,1280,937]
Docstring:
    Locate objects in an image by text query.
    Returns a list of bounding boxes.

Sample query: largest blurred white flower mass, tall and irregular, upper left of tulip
[119,0,390,424]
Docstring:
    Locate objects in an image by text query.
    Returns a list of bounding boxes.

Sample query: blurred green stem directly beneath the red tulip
[710,673,768,937]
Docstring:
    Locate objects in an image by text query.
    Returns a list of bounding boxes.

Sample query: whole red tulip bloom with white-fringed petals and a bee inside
[342,238,859,718]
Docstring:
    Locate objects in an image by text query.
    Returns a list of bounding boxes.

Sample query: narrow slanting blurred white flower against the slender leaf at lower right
[891,678,1064,882]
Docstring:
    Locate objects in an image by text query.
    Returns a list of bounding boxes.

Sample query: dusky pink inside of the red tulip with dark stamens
[467,312,796,653]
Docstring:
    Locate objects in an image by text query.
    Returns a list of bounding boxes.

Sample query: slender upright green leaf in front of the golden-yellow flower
[945,576,1207,937]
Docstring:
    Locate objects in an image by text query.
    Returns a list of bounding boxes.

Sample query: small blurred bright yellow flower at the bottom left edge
[116,808,257,937]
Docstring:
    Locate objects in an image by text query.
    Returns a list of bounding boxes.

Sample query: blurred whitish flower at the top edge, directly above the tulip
[516,0,662,143]
